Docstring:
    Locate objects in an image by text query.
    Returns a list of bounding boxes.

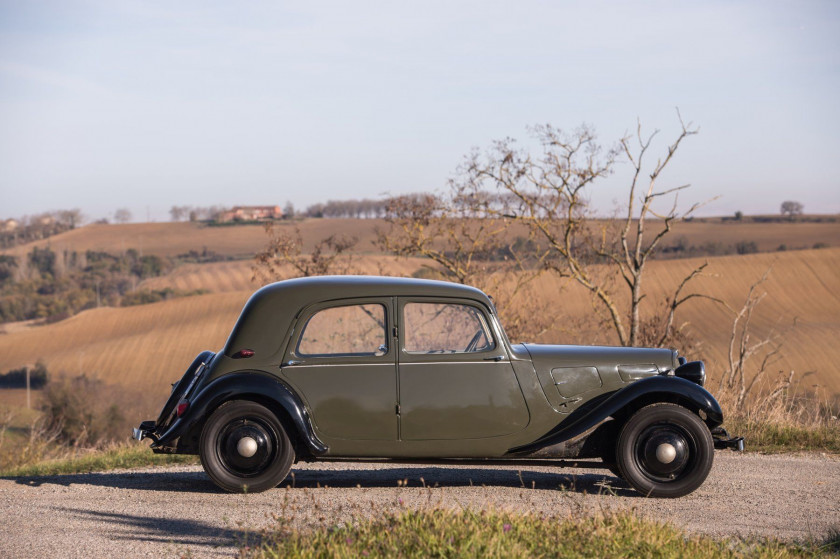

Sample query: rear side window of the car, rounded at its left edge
[296,304,388,357]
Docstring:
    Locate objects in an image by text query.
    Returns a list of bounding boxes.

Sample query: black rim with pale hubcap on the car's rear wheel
[216,418,279,478]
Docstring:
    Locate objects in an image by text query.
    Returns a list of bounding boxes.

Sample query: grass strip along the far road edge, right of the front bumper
[725,417,840,454]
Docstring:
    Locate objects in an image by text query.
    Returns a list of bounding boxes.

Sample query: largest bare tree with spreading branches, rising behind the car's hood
[460,113,705,346]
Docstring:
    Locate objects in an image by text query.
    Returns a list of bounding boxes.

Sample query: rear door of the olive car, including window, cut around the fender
[281,298,397,441]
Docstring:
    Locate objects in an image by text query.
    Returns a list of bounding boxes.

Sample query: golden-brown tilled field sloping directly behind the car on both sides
[0,245,840,395]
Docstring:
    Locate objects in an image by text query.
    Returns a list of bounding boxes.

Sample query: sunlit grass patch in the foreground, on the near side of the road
[240,509,840,559]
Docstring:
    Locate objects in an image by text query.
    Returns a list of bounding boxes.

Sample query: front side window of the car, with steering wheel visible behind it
[403,303,494,353]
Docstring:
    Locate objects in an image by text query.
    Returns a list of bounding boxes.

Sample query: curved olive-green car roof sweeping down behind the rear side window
[225,276,493,355]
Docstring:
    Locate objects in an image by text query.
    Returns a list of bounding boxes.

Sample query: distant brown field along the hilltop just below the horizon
[1,218,840,257]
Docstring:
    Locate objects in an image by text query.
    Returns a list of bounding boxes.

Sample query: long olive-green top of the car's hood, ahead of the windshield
[520,344,679,376]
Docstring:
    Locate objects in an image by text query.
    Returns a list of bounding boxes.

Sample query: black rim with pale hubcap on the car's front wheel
[633,423,697,483]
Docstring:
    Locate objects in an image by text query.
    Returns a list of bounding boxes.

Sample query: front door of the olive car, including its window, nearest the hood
[398,297,529,441]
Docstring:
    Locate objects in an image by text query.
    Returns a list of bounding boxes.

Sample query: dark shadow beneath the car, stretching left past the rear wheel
[6,464,638,496]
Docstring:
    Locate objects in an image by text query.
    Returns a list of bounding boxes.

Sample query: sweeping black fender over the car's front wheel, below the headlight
[507,375,723,454]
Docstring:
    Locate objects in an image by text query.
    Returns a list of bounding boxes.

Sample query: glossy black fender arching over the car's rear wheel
[152,371,329,456]
